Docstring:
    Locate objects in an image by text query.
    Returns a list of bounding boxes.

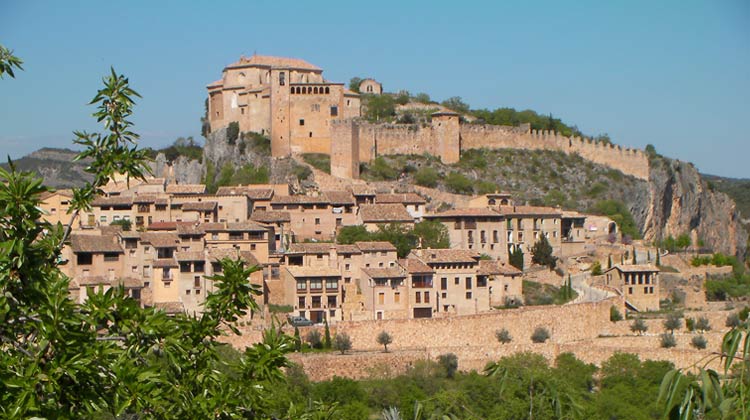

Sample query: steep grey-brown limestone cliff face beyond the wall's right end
[636,158,747,256]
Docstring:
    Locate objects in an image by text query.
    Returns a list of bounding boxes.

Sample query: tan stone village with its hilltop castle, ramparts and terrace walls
[43,55,748,379]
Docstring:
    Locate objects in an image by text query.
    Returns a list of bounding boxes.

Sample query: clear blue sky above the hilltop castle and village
[0,0,750,177]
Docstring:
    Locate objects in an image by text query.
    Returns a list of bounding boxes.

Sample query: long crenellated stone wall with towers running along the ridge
[331,112,649,180]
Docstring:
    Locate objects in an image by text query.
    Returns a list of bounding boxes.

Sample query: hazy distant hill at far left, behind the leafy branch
[2,147,93,188]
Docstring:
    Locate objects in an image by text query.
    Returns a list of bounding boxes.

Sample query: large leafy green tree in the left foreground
[0,70,300,418]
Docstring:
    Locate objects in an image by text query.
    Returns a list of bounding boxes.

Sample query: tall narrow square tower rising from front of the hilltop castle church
[270,69,292,157]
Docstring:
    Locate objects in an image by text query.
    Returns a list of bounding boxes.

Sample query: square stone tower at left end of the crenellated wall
[331,119,359,179]
